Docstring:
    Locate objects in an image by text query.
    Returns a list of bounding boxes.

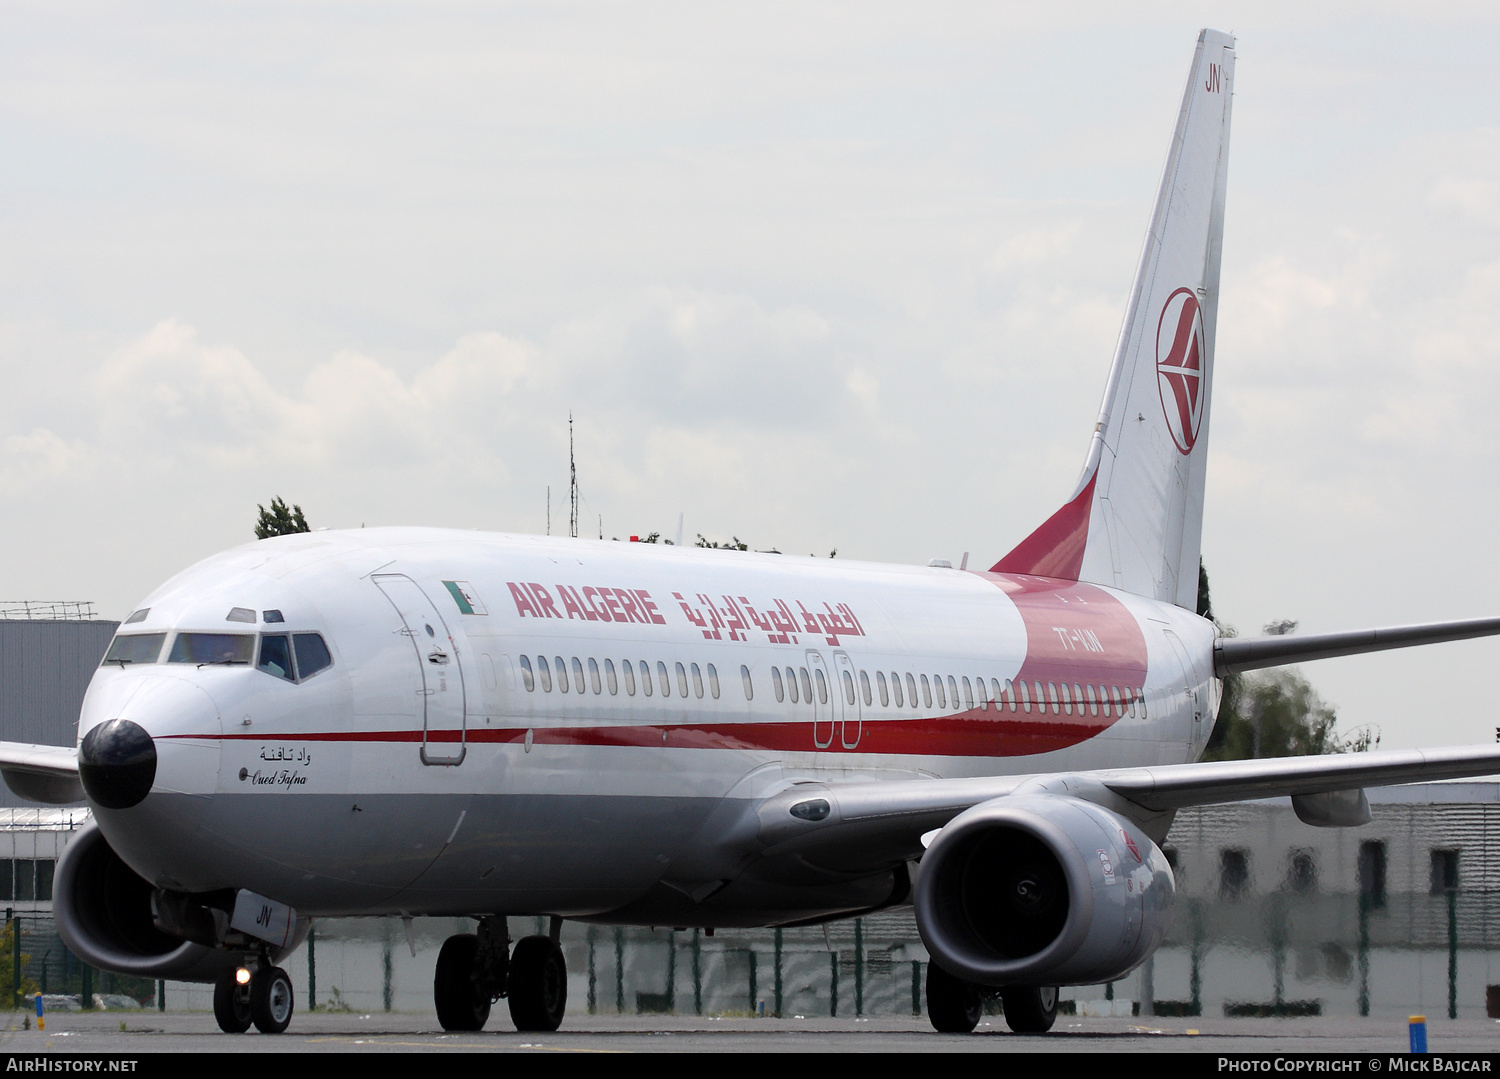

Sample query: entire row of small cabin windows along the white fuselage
[521,656,1146,719]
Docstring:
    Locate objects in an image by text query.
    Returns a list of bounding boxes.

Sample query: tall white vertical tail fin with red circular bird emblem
[993,30,1235,611]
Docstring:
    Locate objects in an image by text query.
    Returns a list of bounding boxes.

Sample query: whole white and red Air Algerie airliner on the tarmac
[0,30,1500,1031]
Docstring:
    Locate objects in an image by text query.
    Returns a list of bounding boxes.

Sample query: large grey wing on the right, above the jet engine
[758,746,1500,872]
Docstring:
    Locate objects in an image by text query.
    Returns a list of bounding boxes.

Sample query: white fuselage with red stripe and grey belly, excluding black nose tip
[80,528,1218,924]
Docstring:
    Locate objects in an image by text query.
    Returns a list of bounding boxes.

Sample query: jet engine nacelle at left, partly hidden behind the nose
[53,821,297,981]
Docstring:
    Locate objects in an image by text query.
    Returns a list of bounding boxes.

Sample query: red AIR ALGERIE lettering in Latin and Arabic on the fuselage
[506,581,864,645]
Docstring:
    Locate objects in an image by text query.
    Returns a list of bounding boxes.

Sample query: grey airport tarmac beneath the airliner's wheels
[0,1008,1500,1070]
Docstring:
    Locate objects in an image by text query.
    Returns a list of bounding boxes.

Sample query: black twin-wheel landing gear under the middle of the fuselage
[432,915,567,1031]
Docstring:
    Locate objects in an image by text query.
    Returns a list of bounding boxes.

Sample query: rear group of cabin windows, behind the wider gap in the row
[771,666,1146,719]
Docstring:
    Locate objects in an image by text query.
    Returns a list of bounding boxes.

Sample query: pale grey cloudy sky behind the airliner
[0,0,1500,747]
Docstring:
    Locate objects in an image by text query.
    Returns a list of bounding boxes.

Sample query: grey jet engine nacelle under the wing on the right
[914,794,1176,986]
